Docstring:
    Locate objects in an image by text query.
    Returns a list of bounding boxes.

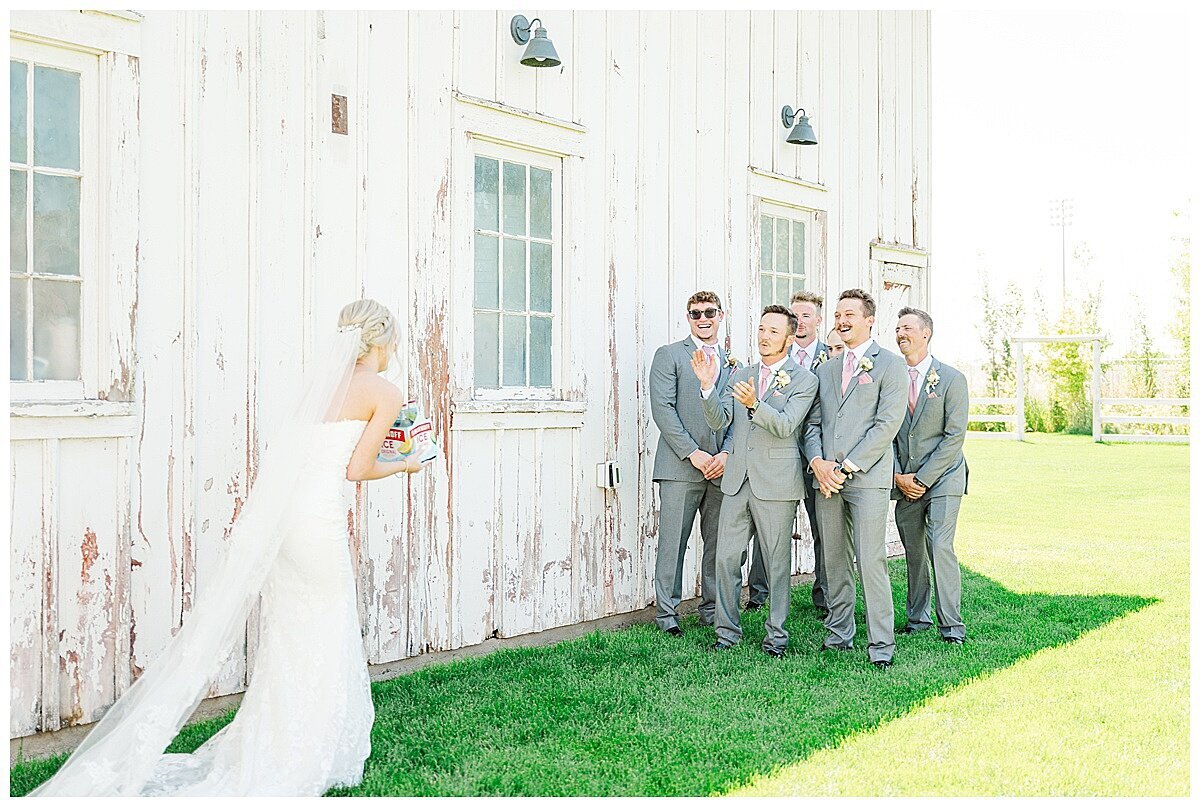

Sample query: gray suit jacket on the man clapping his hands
[703,358,817,502]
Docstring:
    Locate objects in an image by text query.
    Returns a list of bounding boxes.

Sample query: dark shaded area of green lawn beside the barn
[10,560,1157,796]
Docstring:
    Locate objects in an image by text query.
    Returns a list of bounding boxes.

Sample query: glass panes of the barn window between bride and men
[474,154,558,389]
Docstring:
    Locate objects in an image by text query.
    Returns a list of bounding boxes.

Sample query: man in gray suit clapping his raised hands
[691,305,817,658]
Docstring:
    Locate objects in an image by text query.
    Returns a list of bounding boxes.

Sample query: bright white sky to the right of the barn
[930,7,1196,364]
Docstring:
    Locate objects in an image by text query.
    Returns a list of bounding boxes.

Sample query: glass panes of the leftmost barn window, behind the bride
[8,59,85,381]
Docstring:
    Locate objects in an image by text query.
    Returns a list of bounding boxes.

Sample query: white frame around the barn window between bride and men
[468,138,566,401]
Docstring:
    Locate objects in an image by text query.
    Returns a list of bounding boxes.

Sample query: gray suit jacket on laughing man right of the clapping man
[804,341,908,490]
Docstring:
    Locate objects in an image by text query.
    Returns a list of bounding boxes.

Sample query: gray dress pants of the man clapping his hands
[716,483,796,650]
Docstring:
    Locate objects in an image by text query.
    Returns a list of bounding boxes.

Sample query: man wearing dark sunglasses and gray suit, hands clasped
[649,292,732,636]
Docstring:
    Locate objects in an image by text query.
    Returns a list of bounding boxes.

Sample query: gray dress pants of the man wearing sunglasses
[654,479,725,630]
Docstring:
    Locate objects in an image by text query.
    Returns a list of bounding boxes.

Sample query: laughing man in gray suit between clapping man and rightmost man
[804,288,907,669]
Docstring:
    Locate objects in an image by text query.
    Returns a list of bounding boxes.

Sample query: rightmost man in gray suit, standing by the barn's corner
[892,309,970,645]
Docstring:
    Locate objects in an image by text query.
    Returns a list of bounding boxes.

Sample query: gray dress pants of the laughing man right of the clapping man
[816,488,895,662]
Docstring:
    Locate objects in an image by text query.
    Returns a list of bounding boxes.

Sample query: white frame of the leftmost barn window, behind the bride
[8,37,98,401]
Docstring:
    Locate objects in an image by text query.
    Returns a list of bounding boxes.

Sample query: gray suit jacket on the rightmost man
[892,359,970,498]
